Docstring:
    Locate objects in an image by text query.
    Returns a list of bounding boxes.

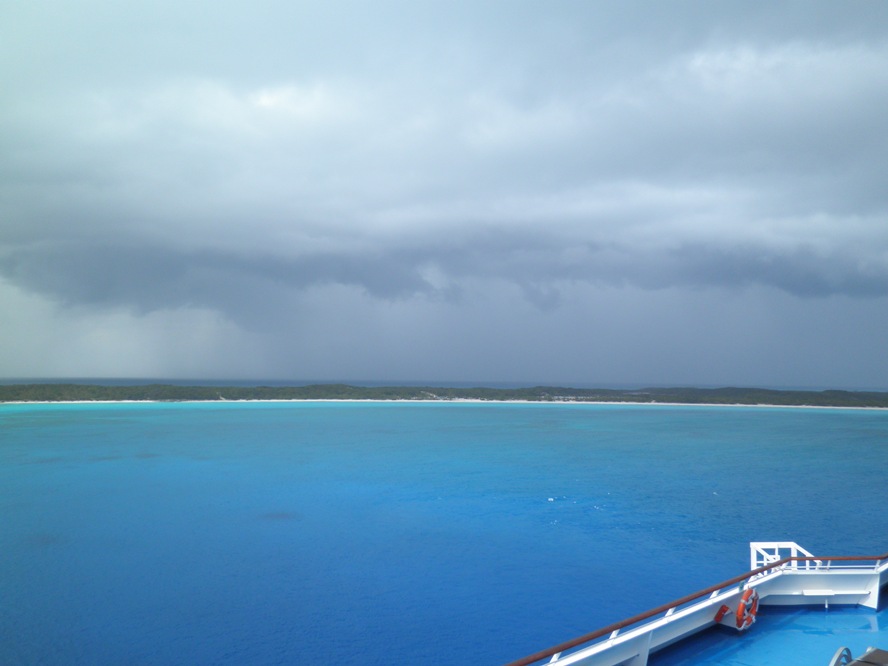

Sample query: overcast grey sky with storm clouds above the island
[0,0,888,389]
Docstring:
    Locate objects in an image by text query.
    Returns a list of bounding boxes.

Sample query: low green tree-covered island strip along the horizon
[0,383,888,408]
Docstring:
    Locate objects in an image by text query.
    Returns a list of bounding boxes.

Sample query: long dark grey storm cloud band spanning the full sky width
[0,223,888,321]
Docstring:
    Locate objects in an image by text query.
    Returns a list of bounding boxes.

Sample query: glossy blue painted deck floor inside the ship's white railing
[649,590,888,666]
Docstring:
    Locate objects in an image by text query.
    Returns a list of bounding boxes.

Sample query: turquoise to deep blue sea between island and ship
[0,403,888,666]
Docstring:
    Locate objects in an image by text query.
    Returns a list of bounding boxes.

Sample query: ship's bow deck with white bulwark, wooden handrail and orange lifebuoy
[509,541,888,666]
